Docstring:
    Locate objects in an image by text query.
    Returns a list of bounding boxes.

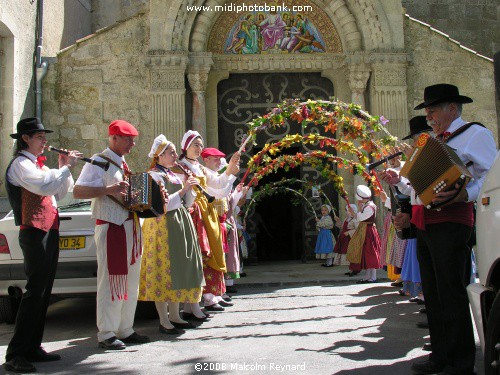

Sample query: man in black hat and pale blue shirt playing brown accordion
[382,84,497,374]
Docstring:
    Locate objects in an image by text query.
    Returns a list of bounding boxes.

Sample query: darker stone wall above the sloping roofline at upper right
[402,0,500,57]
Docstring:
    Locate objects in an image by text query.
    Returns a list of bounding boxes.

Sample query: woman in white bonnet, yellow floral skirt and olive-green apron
[139,134,205,334]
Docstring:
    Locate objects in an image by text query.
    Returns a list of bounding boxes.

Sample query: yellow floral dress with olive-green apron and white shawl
[139,170,205,303]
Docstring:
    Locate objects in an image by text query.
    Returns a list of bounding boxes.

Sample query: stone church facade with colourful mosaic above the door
[0,0,498,258]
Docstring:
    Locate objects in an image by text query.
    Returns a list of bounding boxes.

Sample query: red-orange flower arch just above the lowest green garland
[249,151,380,199]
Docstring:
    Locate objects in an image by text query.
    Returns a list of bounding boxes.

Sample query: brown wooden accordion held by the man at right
[400,134,472,209]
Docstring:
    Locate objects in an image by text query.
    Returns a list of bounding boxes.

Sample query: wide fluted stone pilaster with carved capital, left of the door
[146,50,188,147]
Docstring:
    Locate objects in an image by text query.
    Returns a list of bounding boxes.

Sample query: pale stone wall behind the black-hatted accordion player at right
[405,17,498,140]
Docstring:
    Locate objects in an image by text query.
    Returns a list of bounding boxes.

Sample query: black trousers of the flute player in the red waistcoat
[5,228,59,361]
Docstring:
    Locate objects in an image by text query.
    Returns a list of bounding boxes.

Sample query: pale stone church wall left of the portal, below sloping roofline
[43,14,155,176]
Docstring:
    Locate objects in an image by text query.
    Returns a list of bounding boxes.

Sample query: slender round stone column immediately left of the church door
[187,52,213,142]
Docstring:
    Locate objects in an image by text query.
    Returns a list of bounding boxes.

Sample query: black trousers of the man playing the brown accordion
[417,223,476,374]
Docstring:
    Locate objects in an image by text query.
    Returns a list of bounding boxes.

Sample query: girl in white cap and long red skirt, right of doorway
[348,185,380,284]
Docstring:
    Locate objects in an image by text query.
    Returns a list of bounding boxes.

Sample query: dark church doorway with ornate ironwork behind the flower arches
[217,73,337,261]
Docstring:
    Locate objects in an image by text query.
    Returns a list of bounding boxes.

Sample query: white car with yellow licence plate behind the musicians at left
[0,193,97,323]
